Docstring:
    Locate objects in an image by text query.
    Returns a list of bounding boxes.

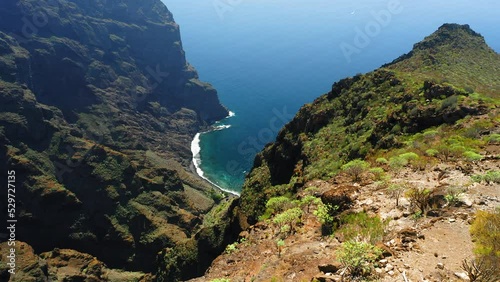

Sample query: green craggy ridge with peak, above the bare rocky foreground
[241,24,500,223]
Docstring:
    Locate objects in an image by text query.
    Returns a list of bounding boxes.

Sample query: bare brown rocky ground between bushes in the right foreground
[190,146,500,282]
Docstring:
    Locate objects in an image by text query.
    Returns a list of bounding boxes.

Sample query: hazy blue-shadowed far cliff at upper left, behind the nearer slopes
[0,0,227,121]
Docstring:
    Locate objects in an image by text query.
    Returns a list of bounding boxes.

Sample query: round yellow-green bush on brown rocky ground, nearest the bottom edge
[336,241,382,277]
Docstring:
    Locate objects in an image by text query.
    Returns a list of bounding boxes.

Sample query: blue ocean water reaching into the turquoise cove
[163,0,500,192]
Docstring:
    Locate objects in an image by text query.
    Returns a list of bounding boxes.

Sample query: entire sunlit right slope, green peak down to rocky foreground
[190,24,500,282]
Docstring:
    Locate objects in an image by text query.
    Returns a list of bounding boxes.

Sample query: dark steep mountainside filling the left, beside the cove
[0,0,232,280]
